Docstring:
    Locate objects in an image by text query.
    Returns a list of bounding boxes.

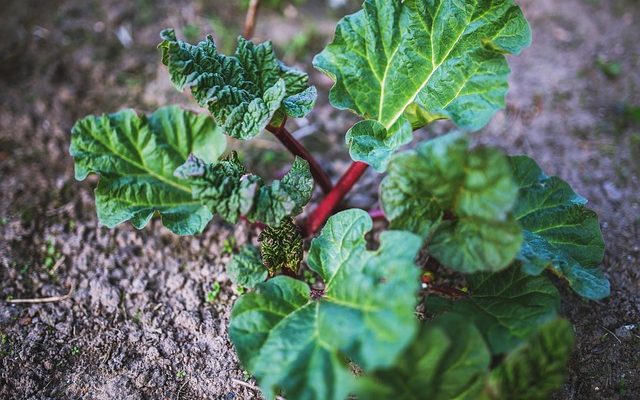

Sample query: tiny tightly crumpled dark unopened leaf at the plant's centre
[259,218,304,275]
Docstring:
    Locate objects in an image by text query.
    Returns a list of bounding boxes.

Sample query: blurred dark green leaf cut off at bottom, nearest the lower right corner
[483,319,574,400]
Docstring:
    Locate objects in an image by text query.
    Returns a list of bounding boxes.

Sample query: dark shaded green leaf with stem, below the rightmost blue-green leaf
[427,267,560,354]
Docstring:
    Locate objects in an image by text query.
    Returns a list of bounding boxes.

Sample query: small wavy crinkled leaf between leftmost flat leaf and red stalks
[175,152,314,226]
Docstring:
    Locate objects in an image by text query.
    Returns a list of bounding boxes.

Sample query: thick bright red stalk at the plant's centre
[307,161,369,235]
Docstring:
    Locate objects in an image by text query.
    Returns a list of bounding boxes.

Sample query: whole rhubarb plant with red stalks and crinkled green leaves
[70,0,610,400]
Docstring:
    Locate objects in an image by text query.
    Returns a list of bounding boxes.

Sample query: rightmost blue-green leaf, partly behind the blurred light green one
[511,156,611,300]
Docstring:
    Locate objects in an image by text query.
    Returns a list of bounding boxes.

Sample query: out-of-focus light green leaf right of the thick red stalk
[381,133,522,273]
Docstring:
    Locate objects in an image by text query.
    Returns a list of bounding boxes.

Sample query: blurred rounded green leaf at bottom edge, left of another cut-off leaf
[358,315,491,400]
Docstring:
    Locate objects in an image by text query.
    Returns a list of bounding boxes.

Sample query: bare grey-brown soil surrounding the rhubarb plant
[0,0,640,400]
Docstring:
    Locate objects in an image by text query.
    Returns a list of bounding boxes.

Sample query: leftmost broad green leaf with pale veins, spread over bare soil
[70,107,226,235]
